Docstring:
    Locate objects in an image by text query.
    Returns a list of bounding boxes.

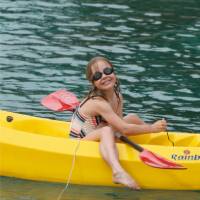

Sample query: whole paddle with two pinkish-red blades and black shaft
[41,89,186,169]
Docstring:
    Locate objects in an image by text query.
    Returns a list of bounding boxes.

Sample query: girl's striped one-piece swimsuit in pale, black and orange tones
[69,106,105,138]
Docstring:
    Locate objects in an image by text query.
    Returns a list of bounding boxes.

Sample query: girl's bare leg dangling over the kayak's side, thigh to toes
[83,126,140,189]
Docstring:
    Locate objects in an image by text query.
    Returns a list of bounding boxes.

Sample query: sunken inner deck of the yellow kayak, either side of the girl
[0,111,200,147]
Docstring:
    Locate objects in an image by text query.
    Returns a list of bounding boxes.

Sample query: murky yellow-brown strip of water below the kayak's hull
[0,177,200,200]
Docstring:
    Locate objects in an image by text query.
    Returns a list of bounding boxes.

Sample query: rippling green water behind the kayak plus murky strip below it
[0,0,200,200]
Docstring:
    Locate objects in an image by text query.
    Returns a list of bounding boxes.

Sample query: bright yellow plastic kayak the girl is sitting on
[0,111,200,190]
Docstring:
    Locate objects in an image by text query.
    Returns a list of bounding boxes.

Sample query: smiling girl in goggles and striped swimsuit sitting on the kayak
[70,57,166,189]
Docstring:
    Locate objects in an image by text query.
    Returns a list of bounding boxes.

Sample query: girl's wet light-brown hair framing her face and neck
[85,56,120,104]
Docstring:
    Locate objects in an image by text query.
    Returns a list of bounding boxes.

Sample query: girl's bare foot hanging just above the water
[113,171,140,190]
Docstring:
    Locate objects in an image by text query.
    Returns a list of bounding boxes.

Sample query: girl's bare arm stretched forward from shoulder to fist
[94,100,167,135]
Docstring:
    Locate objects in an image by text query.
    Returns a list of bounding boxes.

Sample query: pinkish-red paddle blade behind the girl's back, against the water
[41,89,79,111]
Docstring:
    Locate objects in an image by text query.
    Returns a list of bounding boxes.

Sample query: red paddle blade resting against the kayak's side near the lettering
[140,149,187,169]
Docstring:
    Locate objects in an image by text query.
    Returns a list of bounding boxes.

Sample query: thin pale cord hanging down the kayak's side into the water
[56,139,81,200]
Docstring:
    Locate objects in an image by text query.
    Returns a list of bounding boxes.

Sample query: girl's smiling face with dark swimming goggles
[92,60,116,91]
